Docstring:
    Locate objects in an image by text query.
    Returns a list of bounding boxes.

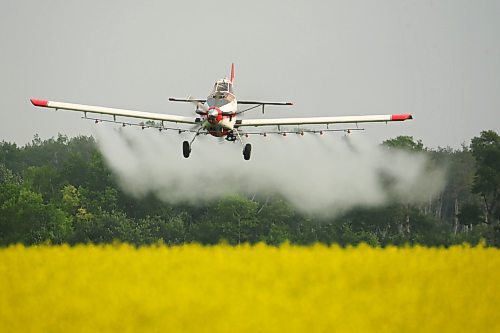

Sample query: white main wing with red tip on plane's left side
[31,99,198,124]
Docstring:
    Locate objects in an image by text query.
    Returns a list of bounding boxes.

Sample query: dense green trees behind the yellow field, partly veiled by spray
[0,131,500,246]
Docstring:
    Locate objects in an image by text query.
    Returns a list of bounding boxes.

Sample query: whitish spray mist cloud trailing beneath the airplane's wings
[96,126,445,216]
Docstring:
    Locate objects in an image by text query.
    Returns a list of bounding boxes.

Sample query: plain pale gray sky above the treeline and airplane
[0,0,500,147]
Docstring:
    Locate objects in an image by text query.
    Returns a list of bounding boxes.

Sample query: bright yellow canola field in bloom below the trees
[0,244,500,332]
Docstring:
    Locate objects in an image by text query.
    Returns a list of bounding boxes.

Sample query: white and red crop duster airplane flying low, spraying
[31,64,413,160]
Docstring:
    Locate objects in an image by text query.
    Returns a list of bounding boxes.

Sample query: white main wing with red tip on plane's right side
[235,114,413,128]
